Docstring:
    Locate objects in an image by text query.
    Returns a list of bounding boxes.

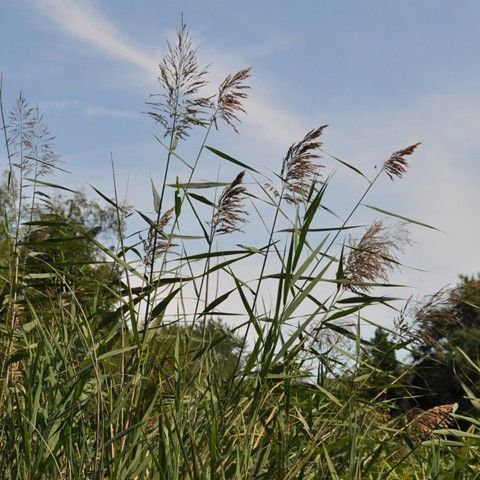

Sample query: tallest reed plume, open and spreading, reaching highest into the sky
[146,22,212,140]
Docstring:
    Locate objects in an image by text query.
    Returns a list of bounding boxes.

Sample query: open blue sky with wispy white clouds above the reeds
[0,0,480,326]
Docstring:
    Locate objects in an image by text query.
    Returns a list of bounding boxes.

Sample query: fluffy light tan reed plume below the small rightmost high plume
[344,221,410,291]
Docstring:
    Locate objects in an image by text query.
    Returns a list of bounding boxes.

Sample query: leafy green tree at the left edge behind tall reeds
[0,176,122,326]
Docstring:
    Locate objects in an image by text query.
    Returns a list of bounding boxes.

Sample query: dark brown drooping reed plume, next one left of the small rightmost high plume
[281,125,327,205]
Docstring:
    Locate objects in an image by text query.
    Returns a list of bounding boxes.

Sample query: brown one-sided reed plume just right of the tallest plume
[213,68,251,133]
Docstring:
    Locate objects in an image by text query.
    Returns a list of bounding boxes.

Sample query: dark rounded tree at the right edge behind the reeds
[410,275,480,409]
